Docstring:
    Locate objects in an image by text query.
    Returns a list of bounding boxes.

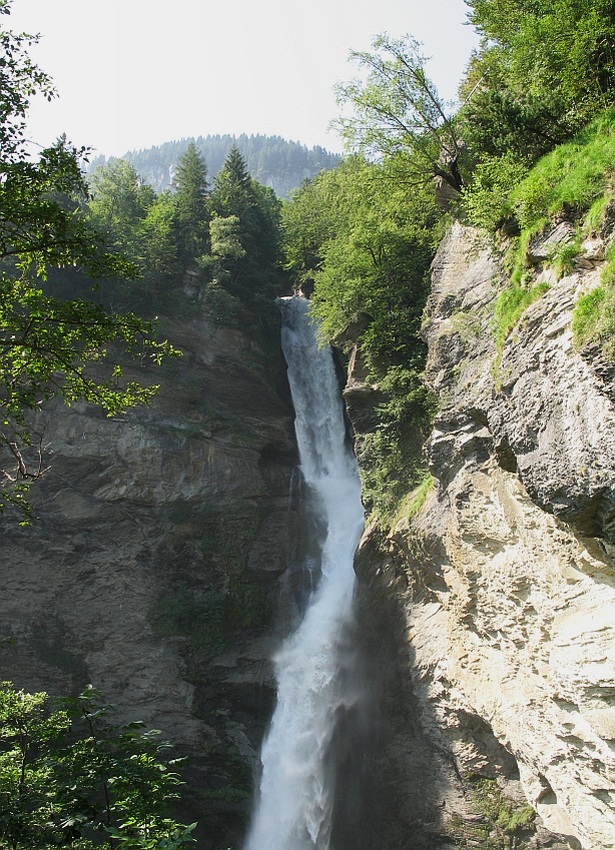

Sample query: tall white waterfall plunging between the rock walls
[244,297,363,850]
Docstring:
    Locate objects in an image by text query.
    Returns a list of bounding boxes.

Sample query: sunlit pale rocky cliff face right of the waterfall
[358,225,615,850]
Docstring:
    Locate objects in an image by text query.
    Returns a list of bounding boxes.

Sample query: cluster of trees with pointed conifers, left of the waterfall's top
[88,121,286,329]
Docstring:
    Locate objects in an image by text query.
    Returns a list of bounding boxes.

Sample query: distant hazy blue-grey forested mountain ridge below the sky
[90,133,341,197]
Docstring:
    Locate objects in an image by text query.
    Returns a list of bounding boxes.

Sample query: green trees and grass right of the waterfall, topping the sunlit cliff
[283,0,615,516]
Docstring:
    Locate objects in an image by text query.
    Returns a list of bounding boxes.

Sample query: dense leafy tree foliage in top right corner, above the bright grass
[461,0,615,161]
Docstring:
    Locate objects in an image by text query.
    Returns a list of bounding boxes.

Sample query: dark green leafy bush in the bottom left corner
[0,682,195,850]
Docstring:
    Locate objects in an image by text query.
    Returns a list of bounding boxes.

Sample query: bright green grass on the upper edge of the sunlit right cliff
[464,109,615,359]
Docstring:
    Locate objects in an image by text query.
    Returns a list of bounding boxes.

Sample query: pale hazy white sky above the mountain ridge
[2,0,476,156]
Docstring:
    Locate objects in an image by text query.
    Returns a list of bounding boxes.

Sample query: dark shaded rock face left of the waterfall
[0,312,296,848]
